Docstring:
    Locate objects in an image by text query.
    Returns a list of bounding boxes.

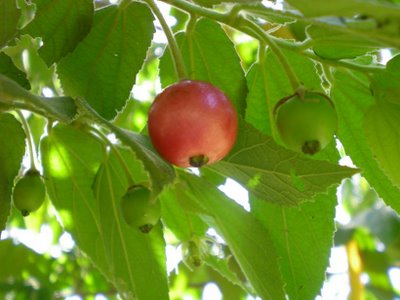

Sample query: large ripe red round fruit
[148,80,238,167]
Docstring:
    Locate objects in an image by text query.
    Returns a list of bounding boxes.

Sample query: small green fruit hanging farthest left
[13,170,46,217]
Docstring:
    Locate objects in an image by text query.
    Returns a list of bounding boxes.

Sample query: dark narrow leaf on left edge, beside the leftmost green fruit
[0,114,25,233]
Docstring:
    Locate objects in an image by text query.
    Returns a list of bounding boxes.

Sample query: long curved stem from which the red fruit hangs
[144,0,188,80]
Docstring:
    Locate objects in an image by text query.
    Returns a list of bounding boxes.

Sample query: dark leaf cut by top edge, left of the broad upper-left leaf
[21,0,94,66]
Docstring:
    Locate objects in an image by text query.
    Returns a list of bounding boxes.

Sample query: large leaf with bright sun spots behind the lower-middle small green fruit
[41,125,168,299]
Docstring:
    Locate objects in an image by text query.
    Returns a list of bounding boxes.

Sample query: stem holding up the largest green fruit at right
[241,18,302,92]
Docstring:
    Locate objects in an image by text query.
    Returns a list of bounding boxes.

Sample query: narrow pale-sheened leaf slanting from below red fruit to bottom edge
[182,174,285,299]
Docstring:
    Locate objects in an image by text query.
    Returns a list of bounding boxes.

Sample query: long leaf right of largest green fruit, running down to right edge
[331,71,400,213]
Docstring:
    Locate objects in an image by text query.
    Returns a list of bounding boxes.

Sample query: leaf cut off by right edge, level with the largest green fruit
[364,101,400,188]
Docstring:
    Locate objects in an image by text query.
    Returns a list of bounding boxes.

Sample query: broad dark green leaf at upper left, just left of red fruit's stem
[57,1,154,119]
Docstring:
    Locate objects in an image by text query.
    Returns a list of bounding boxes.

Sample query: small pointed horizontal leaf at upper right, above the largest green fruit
[307,25,382,59]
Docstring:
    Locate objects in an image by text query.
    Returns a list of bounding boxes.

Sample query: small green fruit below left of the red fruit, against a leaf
[121,186,161,233]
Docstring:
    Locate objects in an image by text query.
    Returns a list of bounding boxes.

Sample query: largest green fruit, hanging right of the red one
[274,92,338,154]
